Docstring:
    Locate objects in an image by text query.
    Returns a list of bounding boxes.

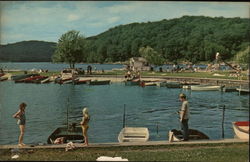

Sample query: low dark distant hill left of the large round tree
[0,41,56,62]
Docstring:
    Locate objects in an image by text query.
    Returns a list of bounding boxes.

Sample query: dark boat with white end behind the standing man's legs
[168,129,209,142]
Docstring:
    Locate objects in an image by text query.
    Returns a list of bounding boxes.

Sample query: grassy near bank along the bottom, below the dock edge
[0,143,249,162]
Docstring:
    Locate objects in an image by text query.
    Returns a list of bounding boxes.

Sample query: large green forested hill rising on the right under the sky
[86,16,250,62]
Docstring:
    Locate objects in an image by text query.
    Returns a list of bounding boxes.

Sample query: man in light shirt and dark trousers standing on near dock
[178,93,189,141]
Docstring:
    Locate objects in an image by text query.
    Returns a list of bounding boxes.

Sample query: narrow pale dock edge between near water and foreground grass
[0,138,246,150]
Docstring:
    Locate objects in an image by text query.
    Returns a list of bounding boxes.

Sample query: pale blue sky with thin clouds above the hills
[0,1,250,44]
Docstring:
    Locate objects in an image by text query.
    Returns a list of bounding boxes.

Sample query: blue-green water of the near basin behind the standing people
[0,81,249,144]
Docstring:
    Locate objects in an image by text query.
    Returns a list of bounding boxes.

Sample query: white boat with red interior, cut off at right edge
[232,121,249,140]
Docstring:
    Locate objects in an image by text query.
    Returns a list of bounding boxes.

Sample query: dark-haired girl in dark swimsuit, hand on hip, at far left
[12,102,27,147]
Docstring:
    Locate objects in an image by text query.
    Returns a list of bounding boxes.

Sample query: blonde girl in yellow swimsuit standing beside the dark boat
[80,107,90,146]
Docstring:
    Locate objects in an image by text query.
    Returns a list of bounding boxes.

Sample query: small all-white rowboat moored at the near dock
[118,127,149,143]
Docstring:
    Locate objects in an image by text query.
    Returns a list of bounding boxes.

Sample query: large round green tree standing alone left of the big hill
[52,30,86,68]
